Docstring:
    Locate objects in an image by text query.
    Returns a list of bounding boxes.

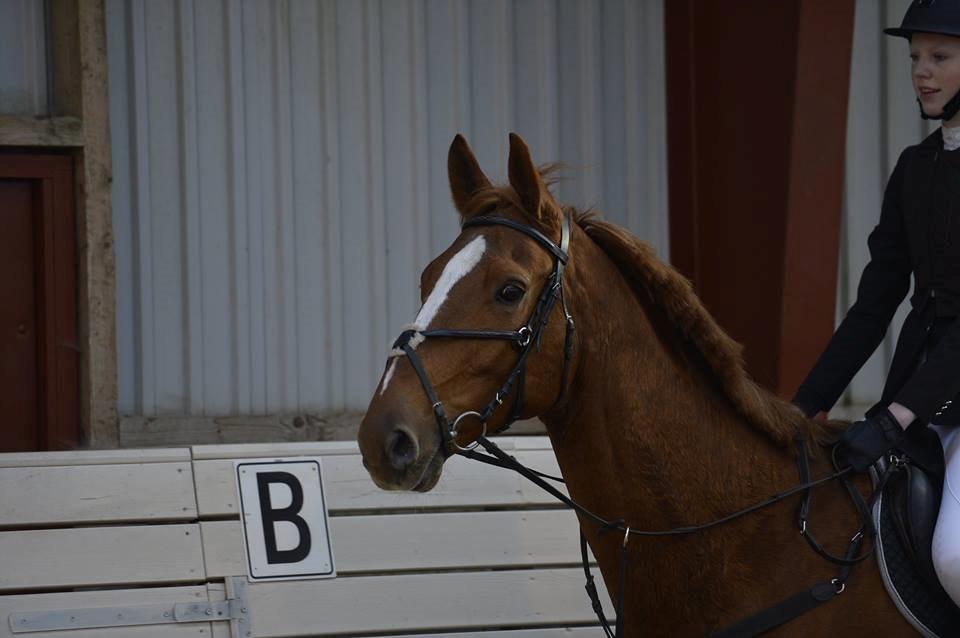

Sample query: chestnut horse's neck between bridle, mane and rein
[544,234,791,527]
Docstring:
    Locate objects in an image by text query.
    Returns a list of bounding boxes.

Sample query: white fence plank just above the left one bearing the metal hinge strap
[0,525,205,591]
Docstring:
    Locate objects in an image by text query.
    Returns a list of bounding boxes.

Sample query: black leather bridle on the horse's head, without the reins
[391,215,574,457]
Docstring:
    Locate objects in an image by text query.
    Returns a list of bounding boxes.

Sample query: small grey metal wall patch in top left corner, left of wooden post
[0,0,47,115]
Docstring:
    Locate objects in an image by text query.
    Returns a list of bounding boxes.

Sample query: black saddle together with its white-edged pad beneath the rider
[872,427,960,638]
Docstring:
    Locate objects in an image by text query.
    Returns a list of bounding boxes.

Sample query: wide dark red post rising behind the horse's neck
[664,0,854,396]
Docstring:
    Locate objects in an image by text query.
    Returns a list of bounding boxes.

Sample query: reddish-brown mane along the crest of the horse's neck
[574,212,828,446]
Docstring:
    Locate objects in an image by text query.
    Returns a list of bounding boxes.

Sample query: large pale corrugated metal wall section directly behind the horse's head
[107,0,667,415]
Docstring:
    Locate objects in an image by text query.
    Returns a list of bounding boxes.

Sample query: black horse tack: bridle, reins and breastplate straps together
[391,215,876,638]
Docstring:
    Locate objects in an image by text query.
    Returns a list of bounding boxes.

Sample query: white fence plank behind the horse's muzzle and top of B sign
[193,450,563,518]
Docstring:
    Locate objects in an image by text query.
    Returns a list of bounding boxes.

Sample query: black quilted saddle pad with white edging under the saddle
[873,484,960,638]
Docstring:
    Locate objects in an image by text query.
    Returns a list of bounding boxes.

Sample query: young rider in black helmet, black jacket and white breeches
[793,0,960,605]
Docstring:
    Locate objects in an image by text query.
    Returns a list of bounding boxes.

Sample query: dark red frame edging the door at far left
[0,149,80,450]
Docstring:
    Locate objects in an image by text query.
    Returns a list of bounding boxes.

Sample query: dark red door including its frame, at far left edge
[0,151,79,452]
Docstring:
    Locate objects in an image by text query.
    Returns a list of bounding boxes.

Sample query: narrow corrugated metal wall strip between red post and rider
[837,0,939,405]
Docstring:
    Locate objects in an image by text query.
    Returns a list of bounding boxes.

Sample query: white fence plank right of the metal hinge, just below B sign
[248,568,612,638]
